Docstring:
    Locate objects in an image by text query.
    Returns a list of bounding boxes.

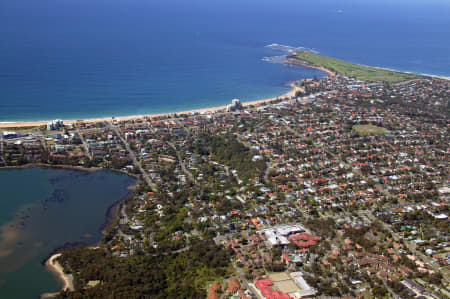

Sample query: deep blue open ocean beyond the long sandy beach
[0,0,450,121]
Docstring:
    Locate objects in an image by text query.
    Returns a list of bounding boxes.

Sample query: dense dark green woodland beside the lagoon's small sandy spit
[58,241,230,298]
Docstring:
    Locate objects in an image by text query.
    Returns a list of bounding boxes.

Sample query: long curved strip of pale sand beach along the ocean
[0,81,301,129]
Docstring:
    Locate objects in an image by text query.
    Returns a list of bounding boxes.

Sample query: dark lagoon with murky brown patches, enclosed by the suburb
[0,168,135,298]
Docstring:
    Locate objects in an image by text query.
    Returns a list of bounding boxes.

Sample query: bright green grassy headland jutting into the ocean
[289,51,418,82]
